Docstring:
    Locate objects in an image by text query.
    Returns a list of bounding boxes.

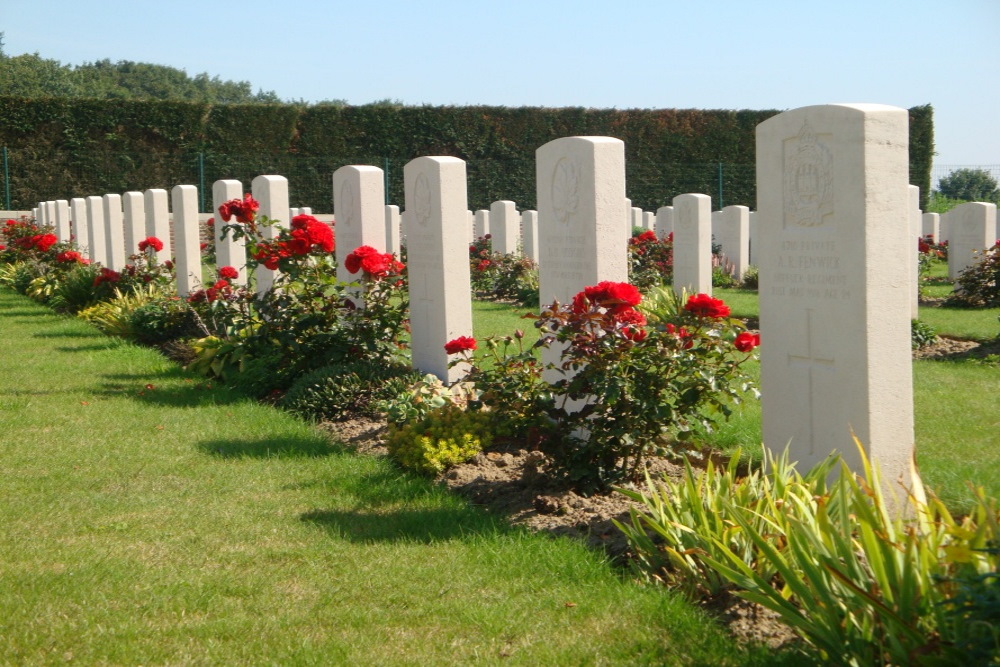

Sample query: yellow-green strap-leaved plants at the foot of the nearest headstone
[630,443,1000,665]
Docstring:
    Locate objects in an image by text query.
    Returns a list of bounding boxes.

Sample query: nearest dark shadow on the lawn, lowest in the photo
[299,507,500,544]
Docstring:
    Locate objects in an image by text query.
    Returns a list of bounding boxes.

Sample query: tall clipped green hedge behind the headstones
[0,97,934,211]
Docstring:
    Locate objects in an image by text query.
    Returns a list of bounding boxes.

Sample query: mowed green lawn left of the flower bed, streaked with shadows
[0,291,780,665]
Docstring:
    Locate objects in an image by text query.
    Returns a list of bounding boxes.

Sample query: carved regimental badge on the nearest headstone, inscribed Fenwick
[784,122,833,227]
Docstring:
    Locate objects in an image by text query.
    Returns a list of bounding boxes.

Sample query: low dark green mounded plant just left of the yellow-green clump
[278,361,420,421]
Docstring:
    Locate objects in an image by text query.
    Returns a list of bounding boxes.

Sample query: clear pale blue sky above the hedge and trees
[0,0,1000,177]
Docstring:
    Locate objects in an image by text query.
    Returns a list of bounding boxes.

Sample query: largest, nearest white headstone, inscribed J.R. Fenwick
[757,104,913,490]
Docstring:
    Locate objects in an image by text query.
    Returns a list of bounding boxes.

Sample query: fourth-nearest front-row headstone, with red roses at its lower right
[333,165,385,282]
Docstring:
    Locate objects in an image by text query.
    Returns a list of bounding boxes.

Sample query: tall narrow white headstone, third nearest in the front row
[403,157,472,382]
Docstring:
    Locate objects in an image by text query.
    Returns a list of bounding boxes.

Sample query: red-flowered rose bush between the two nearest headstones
[453,282,759,493]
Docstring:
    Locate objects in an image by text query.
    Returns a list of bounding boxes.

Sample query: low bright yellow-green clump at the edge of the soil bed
[386,403,492,475]
